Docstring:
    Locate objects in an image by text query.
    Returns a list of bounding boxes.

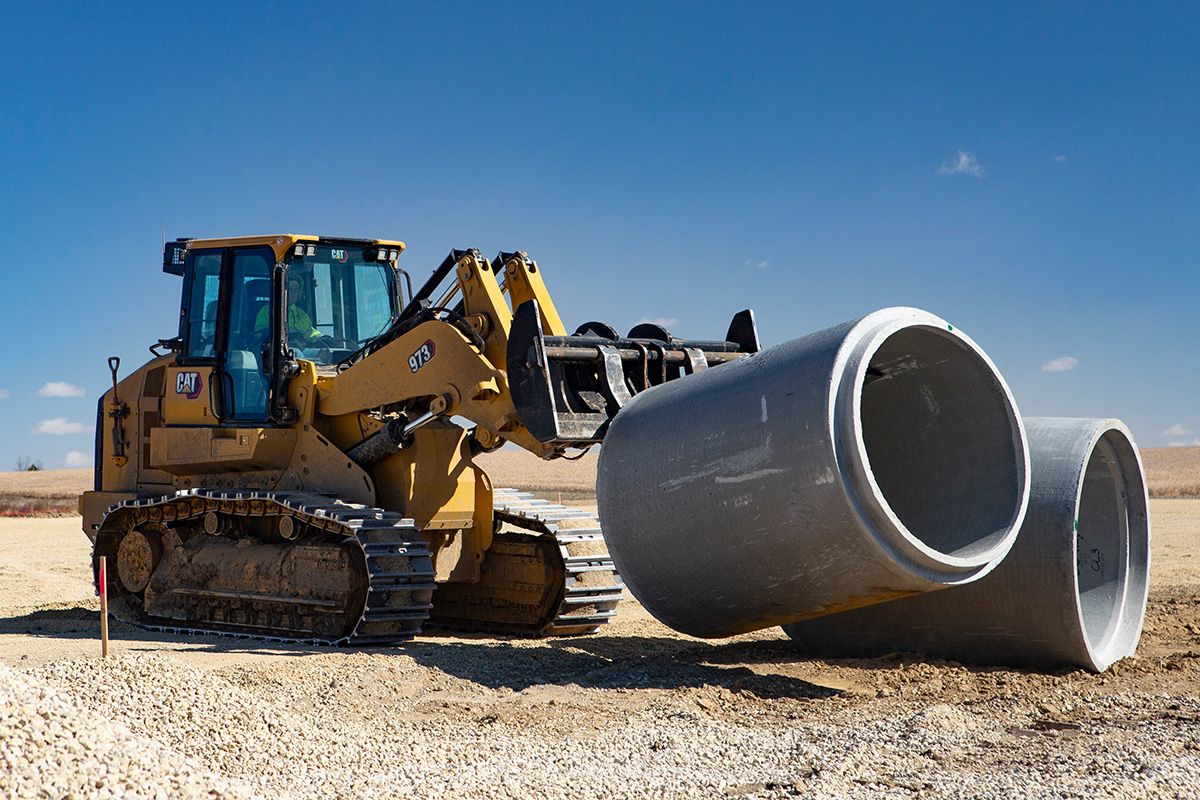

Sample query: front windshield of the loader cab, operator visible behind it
[288,243,398,366]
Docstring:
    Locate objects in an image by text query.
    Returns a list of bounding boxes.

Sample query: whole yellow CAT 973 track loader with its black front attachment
[79,234,758,644]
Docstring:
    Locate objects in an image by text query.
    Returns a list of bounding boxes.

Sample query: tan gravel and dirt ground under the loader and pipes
[0,500,1200,798]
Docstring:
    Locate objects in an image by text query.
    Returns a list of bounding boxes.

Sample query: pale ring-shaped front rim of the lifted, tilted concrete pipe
[830,307,1030,585]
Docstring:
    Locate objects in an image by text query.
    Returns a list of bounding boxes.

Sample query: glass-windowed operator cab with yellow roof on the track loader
[163,235,404,421]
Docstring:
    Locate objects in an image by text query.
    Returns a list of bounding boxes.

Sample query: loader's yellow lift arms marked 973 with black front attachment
[318,249,758,458]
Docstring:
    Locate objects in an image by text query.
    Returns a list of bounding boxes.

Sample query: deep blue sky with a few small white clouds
[0,2,1200,469]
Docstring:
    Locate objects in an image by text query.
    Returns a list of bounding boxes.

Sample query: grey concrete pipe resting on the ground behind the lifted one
[784,417,1150,672]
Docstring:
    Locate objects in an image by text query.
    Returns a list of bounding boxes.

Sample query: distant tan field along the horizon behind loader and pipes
[0,447,1200,517]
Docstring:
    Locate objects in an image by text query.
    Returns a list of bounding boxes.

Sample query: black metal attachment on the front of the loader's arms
[506,300,758,445]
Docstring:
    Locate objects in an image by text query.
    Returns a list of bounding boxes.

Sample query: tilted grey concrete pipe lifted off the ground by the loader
[596,308,1030,637]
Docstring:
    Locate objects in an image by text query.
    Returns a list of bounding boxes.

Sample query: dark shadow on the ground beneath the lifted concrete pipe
[402,636,840,699]
